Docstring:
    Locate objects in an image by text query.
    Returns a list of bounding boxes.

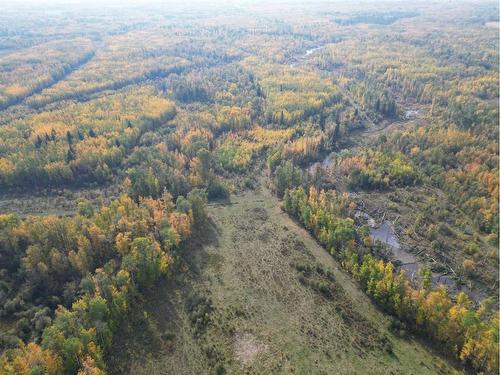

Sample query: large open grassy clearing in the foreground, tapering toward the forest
[110,181,456,375]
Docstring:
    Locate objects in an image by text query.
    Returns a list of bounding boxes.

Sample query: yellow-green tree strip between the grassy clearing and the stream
[283,187,499,374]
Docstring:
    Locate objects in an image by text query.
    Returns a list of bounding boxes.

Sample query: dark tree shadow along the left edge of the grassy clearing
[106,218,218,375]
